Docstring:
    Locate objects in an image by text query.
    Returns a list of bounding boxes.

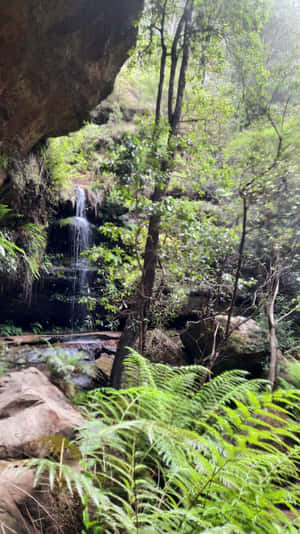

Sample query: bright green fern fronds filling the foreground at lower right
[30,353,300,534]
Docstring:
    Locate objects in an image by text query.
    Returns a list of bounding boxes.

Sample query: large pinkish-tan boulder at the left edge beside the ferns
[0,367,82,459]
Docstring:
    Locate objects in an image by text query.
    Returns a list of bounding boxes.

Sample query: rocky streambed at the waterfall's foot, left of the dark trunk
[0,332,120,390]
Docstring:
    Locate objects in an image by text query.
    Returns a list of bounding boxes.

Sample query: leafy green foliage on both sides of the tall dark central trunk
[96,116,238,326]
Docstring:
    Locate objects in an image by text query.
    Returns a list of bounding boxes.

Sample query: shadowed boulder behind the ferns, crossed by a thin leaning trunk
[181,315,269,376]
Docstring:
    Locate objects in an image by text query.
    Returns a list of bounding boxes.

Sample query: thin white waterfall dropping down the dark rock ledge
[71,186,92,331]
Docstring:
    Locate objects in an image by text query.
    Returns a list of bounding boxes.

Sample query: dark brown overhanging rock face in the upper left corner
[0,0,143,156]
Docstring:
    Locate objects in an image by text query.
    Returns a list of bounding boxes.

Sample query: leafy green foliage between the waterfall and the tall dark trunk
[90,132,155,313]
